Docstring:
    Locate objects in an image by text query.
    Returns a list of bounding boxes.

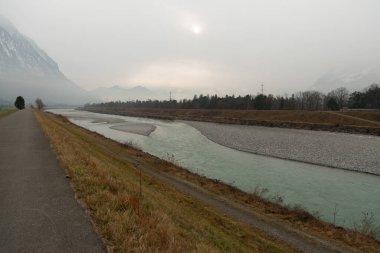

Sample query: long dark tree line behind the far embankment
[85,84,380,110]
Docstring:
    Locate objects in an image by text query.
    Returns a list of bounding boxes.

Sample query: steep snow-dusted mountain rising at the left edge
[0,16,94,105]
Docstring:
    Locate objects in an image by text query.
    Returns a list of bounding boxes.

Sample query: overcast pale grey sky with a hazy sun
[0,0,380,94]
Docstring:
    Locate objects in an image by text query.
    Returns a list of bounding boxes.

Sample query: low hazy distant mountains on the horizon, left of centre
[91,85,161,102]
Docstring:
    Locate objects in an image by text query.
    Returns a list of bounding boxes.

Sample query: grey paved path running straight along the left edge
[0,110,106,253]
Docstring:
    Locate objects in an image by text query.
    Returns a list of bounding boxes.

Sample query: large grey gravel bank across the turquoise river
[185,121,380,175]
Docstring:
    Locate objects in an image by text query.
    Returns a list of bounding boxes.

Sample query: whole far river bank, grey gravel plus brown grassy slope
[81,108,380,175]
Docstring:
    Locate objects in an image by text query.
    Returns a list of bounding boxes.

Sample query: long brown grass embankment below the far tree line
[85,107,380,135]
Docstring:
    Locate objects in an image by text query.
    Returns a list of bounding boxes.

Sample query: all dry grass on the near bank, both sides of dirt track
[35,112,380,252]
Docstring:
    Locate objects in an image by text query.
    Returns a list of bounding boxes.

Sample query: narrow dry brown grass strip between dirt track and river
[151,159,380,253]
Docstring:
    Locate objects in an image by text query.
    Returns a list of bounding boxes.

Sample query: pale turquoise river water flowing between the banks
[50,109,380,231]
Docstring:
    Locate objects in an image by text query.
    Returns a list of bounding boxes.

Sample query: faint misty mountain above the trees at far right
[312,69,380,92]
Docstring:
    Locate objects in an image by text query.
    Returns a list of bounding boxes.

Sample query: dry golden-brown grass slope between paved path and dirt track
[35,111,297,252]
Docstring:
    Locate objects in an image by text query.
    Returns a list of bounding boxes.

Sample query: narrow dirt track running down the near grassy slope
[103,147,355,253]
